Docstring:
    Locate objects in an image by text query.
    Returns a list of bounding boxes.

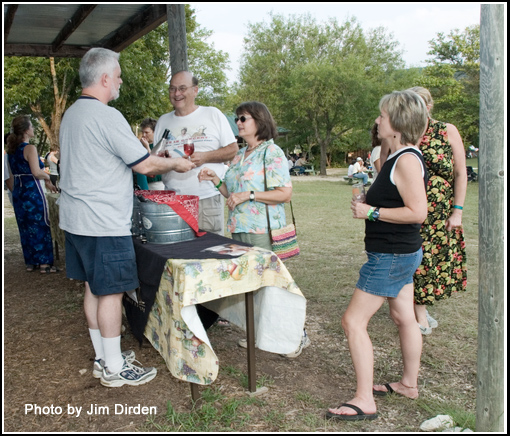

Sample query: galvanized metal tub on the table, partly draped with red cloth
[136,199,196,244]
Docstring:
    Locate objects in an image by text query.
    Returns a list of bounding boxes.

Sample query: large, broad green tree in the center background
[239,14,412,175]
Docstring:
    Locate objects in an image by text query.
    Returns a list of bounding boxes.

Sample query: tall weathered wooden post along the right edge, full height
[476,4,505,433]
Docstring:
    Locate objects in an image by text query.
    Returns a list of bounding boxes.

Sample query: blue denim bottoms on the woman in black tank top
[356,247,423,298]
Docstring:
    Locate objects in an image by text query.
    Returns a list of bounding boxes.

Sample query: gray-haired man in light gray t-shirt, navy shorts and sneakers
[59,48,195,387]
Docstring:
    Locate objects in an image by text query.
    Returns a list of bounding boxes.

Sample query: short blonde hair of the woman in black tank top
[379,89,428,145]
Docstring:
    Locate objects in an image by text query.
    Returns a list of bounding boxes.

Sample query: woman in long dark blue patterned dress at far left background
[7,115,57,274]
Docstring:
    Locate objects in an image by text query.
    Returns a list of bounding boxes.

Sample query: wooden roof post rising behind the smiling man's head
[166,4,188,75]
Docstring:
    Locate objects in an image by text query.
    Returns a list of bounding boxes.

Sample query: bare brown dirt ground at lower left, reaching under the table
[4,233,344,432]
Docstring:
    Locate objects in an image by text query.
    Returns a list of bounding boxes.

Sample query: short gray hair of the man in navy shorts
[80,47,120,88]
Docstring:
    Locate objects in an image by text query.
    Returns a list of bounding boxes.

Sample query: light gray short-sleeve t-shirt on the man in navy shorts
[59,97,149,237]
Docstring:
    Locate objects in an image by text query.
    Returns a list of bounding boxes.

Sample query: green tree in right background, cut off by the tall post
[420,25,480,147]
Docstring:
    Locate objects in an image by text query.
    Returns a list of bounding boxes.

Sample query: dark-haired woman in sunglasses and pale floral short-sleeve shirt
[198,101,310,357]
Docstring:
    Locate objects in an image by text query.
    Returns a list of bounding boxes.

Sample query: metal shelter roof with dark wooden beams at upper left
[4,3,167,57]
